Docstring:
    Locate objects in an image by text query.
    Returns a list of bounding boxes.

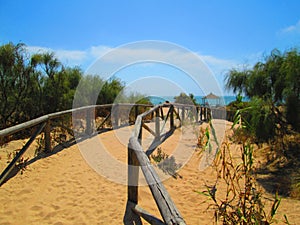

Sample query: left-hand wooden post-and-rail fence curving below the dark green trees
[0,104,152,185]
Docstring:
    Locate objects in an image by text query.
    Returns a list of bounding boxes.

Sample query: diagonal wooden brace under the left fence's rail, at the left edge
[0,122,46,185]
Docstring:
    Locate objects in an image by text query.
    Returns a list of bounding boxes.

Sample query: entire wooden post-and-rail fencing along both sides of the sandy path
[0,104,211,225]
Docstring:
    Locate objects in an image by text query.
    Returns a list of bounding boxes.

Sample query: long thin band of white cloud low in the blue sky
[27,45,237,73]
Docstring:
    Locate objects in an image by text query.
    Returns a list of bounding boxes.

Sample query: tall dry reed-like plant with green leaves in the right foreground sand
[198,111,287,224]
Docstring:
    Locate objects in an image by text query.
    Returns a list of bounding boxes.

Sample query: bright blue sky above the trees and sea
[0,0,300,95]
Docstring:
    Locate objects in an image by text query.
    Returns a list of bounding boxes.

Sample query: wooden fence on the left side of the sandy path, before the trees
[0,104,152,185]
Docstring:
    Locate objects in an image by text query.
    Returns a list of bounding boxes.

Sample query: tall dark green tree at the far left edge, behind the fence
[0,43,36,128]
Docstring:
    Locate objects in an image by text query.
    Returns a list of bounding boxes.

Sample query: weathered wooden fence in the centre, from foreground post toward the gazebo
[124,104,210,225]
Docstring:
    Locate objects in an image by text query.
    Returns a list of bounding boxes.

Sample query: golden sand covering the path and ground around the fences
[0,121,300,225]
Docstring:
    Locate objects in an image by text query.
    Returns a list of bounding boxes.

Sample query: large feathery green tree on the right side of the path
[226,49,300,141]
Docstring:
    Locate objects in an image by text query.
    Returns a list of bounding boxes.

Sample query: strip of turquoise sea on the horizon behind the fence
[149,96,249,106]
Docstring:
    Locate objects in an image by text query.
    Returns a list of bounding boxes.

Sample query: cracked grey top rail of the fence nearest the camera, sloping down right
[129,137,185,225]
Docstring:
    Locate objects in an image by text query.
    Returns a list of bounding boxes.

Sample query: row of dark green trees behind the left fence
[0,43,148,129]
